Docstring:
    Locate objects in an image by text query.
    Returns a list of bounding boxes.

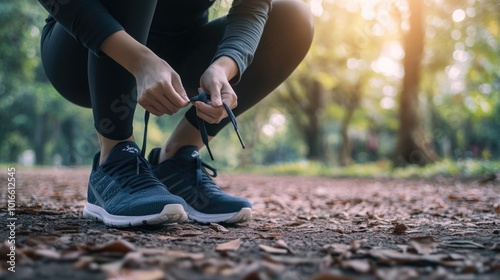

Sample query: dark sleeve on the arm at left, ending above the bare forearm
[38,0,124,55]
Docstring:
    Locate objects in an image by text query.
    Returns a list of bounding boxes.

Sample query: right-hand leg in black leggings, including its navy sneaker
[149,0,312,223]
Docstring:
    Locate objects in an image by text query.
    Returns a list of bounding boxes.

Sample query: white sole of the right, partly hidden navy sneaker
[187,205,252,224]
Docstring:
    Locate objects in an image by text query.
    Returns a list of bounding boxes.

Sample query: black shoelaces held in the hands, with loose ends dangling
[141,91,245,160]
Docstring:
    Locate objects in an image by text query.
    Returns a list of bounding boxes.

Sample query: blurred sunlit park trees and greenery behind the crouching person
[0,0,500,174]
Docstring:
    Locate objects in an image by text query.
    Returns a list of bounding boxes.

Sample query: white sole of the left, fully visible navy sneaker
[83,202,188,227]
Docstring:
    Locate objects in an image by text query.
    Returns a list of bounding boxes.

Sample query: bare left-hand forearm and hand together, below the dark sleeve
[100,31,189,116]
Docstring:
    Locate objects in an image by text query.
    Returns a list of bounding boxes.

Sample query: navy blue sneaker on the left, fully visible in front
[83,141,187,227]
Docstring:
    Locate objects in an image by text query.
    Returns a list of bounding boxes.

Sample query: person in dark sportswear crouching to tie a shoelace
[39,0,313,227]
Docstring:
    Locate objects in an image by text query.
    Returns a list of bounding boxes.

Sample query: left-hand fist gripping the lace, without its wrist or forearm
[133,53,189,116]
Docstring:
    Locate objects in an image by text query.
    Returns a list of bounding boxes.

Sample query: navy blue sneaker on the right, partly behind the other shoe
[148,146,252,223]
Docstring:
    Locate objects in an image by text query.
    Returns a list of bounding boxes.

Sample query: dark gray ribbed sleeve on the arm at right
[213,0,272,84]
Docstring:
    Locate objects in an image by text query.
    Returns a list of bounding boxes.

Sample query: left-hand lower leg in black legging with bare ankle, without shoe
[88,0,156,163]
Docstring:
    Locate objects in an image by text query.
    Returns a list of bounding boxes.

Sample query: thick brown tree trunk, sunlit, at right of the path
[393,0,437,167]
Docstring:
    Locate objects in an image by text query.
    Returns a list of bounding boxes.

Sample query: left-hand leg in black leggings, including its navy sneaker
[42,0,187,227]
